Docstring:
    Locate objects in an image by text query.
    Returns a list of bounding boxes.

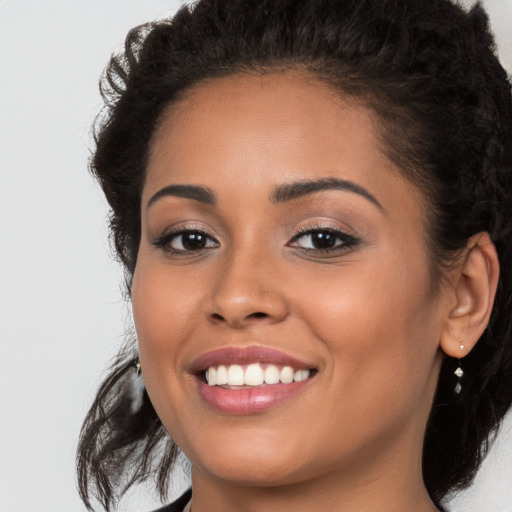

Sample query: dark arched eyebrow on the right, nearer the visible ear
[270,178,386,211]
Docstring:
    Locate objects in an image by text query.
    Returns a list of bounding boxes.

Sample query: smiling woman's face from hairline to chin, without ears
[133,73,443,485]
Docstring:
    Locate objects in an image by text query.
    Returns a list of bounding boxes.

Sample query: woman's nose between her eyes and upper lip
[206,247,288,329]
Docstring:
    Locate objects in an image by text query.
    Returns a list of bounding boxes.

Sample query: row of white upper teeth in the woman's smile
[205,363,310,386]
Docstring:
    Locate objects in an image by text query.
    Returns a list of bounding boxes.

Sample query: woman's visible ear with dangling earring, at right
[441,233,500,358]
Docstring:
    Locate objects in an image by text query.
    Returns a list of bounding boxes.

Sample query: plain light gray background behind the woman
[0,0,512,512]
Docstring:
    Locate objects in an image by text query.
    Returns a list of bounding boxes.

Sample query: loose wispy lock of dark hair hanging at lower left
[77,343,179,510]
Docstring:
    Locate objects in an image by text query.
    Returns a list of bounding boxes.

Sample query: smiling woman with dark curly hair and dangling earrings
[78,0,512,512]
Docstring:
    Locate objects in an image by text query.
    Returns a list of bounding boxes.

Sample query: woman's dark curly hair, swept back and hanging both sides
[77,0,512,510]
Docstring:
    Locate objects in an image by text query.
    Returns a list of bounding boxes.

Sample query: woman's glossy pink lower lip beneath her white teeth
[197,377,313,414]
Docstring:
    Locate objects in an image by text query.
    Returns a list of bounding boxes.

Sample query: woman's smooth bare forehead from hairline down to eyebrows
[144,72,418,212]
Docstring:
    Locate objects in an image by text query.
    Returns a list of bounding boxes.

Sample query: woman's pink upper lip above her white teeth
[190,345,314,373]
